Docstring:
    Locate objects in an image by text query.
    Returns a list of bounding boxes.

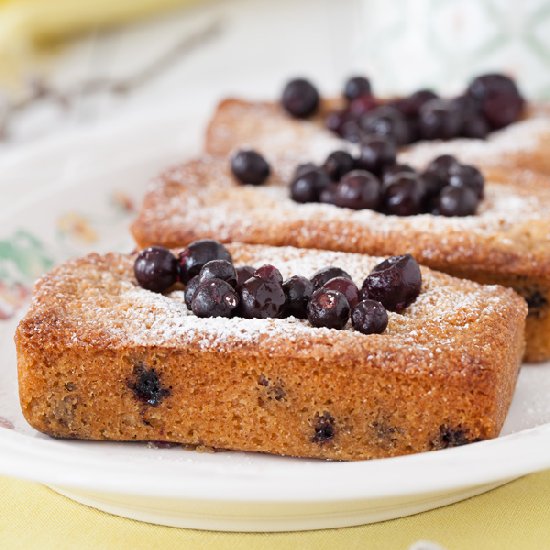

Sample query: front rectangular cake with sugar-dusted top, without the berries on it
[16,244,527,460]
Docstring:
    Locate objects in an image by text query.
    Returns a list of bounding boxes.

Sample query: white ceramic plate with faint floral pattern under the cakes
[0,105,550,531]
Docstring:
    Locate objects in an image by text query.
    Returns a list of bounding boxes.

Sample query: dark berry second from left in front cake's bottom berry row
[241,277,286,319]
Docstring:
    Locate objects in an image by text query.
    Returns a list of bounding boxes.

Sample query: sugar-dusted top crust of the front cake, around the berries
[19,244,527,380]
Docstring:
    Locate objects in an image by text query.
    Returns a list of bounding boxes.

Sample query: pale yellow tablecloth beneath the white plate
[0,472,550,550]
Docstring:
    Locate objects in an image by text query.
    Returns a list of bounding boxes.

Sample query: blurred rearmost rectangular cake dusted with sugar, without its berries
[204,99,550,176]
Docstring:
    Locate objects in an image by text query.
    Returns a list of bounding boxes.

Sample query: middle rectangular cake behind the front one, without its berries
[132,157,550,361]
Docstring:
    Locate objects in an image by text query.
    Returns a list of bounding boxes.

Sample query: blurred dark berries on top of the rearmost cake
[281,73,525,146]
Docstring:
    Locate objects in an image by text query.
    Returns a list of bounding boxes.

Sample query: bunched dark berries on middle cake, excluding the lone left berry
[290,148,484,216]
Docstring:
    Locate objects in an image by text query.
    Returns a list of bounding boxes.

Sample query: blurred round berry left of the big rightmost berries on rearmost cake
[418,99,463,140]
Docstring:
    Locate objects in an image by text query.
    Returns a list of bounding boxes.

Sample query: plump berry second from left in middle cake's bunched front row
[332,170,382,210]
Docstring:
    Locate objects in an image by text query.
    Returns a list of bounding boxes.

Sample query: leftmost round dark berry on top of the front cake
[134,246,178,292]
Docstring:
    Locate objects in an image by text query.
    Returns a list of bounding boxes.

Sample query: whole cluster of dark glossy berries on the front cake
[134,240,422,334]
